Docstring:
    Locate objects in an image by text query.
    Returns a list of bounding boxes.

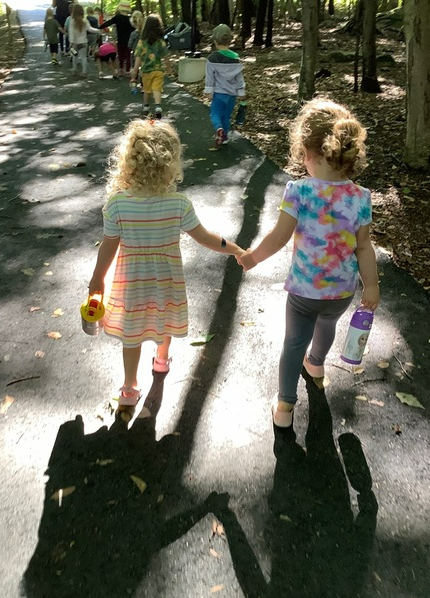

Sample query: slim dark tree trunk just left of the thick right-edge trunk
[361,0,381,93]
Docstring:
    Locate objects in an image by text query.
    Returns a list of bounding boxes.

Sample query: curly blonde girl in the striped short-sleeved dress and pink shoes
[89,119,243,407]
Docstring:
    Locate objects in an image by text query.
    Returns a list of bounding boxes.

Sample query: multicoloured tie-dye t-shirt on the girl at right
[279,177,372,299]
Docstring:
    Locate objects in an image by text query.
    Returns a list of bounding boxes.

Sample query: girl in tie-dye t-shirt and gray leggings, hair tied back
[239,99,379,428]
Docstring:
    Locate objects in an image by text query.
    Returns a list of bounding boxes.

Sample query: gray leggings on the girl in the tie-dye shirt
[279,293,353,404]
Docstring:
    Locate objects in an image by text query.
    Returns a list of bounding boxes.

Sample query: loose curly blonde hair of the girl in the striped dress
[106,119,182,195]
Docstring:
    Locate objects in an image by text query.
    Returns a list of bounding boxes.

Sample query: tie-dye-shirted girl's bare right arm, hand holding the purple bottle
[355,224,379,311]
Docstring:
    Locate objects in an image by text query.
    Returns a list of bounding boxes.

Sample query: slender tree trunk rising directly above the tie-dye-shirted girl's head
[298,0,318,102]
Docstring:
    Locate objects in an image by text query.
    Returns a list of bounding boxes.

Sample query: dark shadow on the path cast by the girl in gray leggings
[216,372,378,598]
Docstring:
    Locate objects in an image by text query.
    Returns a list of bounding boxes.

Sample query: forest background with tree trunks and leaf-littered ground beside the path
[0,0,430,292]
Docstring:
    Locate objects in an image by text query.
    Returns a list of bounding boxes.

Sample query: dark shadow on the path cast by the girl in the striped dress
[23,373,227,598]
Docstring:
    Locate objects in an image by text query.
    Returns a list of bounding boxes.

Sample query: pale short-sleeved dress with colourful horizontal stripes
[103,191,200,348]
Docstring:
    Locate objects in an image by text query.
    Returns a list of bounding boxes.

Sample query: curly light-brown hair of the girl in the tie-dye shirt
[290,98,367,176]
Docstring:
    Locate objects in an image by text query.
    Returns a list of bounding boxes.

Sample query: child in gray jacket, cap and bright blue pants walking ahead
[204,24,245,146]
